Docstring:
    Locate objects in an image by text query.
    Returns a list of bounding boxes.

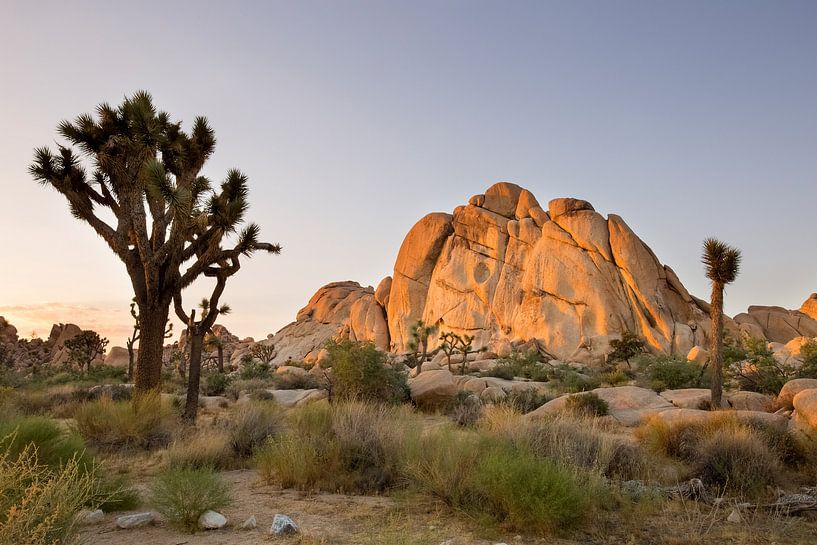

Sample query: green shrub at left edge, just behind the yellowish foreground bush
[0,416,93,469]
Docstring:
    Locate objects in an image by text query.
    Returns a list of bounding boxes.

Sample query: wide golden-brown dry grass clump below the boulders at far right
[636,412,802,495]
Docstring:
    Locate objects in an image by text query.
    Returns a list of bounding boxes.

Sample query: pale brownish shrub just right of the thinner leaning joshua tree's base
[226,402,284,457]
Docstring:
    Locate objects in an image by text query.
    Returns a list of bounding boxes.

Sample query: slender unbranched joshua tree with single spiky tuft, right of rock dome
[701,238,741,410]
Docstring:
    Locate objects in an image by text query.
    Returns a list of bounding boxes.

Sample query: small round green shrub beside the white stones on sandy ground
[151,467,231,533]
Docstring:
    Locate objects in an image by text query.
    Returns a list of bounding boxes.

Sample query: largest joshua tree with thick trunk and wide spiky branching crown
[30,91,280,393]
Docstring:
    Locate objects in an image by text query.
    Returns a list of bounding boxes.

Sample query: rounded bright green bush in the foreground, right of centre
[469,443,590,532]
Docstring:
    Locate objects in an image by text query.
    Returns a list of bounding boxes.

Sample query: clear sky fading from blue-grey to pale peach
[0,0,817,345]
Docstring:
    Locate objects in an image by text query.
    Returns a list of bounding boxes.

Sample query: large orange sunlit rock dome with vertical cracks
[387,183,709,363]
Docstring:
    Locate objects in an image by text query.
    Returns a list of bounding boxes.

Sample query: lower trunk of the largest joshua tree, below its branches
[134,302,170,395]
